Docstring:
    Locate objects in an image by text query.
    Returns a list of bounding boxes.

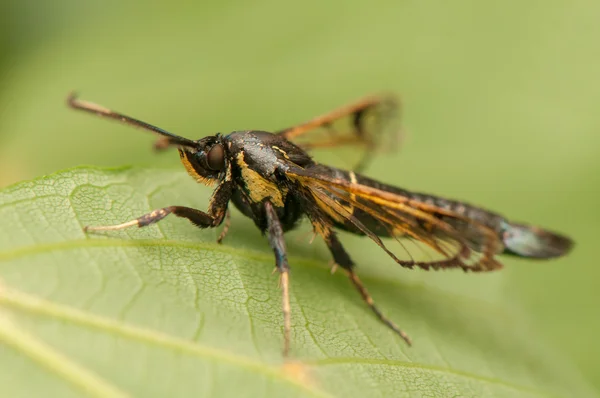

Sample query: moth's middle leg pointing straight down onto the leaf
[265,201,292,356]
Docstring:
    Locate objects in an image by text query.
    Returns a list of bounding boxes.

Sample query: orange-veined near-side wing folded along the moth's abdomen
[287,168,503,271]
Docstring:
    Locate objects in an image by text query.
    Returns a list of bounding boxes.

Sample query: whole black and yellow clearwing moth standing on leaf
[68,96,572,355]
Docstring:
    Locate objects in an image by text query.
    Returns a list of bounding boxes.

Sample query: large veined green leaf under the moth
[0,168,592,397]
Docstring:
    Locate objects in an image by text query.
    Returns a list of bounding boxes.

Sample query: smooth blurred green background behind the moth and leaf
[0,0,600,387]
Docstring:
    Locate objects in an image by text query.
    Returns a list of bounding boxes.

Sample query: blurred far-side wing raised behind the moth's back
[277,95,402,170]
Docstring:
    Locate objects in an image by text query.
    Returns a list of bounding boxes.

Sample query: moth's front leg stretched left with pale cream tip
[83,206,223,232]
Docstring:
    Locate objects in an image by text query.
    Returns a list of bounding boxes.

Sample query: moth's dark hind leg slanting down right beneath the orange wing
[325,231,412,345]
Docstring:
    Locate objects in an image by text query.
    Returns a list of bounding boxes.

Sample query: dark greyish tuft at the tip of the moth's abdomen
[502,223,573,258]
